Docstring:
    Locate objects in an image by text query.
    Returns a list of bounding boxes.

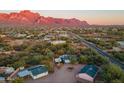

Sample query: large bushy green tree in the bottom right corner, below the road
[101,64,124,82]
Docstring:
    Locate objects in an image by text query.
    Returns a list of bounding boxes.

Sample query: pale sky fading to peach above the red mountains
[0,10,124,25]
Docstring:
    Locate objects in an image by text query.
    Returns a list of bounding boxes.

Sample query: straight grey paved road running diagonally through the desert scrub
[69,32,124,69]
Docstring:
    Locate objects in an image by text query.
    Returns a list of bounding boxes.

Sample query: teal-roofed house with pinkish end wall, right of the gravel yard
[76,65,99,83]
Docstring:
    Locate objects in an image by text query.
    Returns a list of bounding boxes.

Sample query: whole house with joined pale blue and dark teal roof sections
[18,65,48,79]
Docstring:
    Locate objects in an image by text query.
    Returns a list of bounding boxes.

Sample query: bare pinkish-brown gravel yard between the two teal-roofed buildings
[26,64,83,83]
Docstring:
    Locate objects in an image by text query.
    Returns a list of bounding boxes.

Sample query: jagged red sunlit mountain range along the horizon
[0,10,89,27]
